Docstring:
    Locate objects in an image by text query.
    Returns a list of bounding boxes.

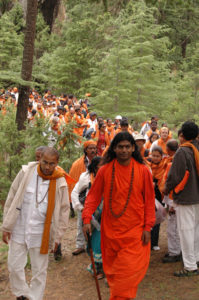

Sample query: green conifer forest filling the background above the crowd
[0,0,199,126]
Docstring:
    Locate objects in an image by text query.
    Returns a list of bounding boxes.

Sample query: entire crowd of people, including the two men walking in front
[0,88,199,300]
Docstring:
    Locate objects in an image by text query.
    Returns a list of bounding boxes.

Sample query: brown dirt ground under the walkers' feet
[0,218,199,300]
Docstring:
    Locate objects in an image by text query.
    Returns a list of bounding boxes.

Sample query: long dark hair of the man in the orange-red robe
[102,132,143,165]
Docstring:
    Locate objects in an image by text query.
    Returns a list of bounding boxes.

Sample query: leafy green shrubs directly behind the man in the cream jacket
[0,105,83,214]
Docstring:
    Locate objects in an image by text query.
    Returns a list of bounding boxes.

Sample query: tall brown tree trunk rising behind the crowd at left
[16,0,38,130]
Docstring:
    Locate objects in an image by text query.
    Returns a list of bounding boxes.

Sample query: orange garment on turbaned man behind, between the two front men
[68,155,86,202]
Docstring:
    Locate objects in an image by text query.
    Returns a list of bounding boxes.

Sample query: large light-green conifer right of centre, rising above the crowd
[86,2,172,121]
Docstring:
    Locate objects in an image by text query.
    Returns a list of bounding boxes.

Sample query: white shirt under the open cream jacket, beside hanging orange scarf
[11,166,50,249]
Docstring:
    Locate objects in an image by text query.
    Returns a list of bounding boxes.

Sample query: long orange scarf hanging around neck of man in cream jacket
[37,164,72,254]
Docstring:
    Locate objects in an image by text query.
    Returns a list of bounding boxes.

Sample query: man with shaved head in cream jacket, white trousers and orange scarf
[2,147,70,300]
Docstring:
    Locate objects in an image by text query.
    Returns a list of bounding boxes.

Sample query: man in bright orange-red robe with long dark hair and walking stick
[82,132,155,300]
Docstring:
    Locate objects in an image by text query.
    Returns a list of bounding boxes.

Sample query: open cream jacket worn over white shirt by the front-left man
[2,162,70,249]
